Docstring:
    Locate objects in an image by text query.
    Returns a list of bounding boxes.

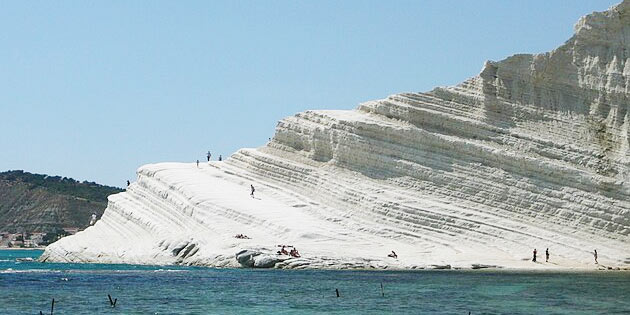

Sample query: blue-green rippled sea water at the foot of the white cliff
[0,250,630,314]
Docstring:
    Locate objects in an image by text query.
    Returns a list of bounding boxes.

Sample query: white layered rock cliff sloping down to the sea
[41,1,630,269]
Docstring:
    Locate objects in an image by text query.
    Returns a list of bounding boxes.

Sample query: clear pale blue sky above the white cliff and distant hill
[0,0,618,186]
